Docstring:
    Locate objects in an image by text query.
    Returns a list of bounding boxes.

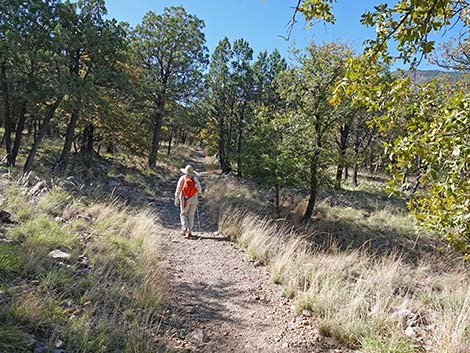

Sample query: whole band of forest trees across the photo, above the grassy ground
[0,1,470,253]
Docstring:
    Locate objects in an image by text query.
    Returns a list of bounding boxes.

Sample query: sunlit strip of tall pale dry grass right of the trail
[219,209,470,353]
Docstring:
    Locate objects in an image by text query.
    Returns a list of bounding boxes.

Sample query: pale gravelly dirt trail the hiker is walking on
[156,152,343,353]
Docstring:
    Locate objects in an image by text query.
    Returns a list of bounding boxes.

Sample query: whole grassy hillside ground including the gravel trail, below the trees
[0,144,470,353]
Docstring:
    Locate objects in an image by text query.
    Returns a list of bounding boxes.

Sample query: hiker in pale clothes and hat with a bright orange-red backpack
[175,164,202,237]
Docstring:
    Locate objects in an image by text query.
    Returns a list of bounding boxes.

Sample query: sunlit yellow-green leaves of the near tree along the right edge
[336,58,470,254]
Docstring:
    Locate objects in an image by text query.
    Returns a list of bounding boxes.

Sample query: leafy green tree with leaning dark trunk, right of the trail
[279,43,351,220]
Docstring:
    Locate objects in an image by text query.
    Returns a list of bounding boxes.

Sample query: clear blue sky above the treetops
[106,0,448,69]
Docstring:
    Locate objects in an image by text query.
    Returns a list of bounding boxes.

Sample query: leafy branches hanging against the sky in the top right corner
[296,0,470,64]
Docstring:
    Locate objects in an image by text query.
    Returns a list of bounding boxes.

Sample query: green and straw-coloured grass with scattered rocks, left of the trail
[0,180,166,353]
